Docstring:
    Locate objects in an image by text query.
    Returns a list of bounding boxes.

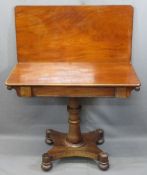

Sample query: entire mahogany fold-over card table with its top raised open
[5,5,140,171]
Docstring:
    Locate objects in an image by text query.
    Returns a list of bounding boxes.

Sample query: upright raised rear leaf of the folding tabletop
[16,6,133,63]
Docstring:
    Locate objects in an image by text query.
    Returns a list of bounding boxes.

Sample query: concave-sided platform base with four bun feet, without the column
[42,129,109,171]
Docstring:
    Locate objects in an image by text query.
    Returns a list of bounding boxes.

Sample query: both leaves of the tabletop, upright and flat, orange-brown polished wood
[6,6,140,87]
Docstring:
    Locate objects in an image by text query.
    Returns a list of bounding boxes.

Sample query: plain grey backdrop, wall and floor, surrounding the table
[0,0,147,175]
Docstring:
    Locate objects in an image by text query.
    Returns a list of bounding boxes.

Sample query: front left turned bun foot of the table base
[41,153,53,171]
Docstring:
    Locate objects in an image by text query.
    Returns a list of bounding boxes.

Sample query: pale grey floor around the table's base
[0,136,147,175]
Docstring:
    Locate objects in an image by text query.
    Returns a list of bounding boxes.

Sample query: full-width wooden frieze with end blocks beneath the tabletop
[9,86,133,98]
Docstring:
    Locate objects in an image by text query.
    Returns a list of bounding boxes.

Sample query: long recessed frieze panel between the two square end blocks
[28,86,115,97]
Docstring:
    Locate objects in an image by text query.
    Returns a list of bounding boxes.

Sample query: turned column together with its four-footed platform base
[41,98,109,171]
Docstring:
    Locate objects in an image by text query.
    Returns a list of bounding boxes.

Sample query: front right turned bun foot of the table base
[98,153,109,171]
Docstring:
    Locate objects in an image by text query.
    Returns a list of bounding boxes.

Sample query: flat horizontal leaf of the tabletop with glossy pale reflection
[6,62,140,87]
